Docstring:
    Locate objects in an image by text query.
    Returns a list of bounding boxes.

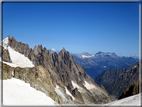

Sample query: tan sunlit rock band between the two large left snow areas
[3,63,63,104]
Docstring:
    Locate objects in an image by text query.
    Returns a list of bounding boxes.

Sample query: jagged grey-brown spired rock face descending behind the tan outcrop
[3,36,112,104]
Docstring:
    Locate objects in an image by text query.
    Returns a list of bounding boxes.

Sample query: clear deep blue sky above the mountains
[3,3,139,56]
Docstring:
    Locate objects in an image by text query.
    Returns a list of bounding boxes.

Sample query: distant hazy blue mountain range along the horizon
[72,52,139,78]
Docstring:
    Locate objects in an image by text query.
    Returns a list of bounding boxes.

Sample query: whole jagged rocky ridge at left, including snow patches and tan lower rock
[1,36,113,104]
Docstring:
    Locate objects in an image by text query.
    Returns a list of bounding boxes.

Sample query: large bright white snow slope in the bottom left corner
[3,78,58,106]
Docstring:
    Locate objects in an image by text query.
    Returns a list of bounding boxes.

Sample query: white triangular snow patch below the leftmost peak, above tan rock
[8,46,34,68]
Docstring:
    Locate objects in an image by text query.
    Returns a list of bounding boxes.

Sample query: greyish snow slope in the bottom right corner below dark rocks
[106,94,141,106]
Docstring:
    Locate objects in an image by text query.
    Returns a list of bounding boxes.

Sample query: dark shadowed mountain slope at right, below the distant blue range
[94,63,139,98]
